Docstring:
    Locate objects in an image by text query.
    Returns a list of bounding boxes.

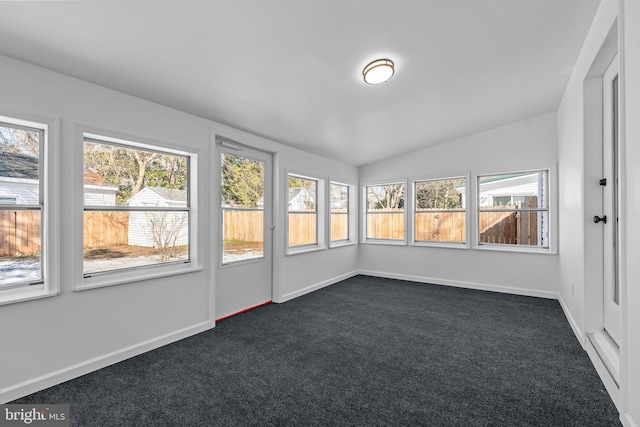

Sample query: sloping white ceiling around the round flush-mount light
[0,0,599,166]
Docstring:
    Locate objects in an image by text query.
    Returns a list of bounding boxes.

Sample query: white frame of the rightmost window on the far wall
[471,166,558,255]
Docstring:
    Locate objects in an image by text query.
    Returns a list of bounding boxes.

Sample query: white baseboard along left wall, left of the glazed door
[0,322,214,403]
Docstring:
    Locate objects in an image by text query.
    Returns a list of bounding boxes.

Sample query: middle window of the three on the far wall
[413,178,467,243]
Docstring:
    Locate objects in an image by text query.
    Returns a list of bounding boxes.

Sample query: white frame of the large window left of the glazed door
[74,130,203,291]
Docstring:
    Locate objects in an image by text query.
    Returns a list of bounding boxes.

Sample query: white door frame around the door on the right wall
[584,15,626,398]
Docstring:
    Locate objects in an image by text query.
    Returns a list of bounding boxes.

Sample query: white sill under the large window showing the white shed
[74,263,203,291]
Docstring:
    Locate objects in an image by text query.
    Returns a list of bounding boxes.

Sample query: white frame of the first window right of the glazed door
[283,169,327,255]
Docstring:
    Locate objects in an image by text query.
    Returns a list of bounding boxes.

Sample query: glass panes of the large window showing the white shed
[83,137,191,277]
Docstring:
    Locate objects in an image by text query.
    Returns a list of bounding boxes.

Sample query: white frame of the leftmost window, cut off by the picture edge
[0,110,60,306]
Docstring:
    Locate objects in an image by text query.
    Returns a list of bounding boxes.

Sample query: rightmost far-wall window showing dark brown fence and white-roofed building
[478,170,549,249]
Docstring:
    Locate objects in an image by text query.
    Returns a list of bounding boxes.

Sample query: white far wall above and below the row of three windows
[360,113,558,298]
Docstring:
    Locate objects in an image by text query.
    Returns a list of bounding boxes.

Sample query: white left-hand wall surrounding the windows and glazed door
[0,56,358,402]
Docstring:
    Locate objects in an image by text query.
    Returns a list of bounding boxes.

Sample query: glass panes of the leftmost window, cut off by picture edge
[0,122,45,289]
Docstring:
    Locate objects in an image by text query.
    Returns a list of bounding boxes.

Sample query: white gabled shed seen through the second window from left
[128,187,189,248]
